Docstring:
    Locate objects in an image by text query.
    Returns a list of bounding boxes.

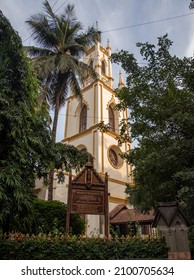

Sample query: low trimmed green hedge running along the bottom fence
[0,237,168,260]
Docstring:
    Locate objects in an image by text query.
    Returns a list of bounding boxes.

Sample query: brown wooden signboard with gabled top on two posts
[66,162,108,237]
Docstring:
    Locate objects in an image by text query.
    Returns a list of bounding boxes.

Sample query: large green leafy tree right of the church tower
[112,35,194,219]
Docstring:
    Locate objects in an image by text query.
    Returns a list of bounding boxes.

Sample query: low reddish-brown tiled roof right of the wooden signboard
[109,204,154,224]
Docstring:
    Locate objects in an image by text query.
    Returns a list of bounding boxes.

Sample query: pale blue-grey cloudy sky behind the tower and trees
[0,0,194,141]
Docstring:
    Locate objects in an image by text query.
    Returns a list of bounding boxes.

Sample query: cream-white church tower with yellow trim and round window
[54,41,131,234]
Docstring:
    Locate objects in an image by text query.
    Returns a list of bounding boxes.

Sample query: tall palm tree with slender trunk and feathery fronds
[25,0,99,200]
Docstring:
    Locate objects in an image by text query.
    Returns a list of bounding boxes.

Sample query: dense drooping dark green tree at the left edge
[0,12,87,231]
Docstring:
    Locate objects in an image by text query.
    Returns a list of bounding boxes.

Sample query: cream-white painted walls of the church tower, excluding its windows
[54,40,132,235]
